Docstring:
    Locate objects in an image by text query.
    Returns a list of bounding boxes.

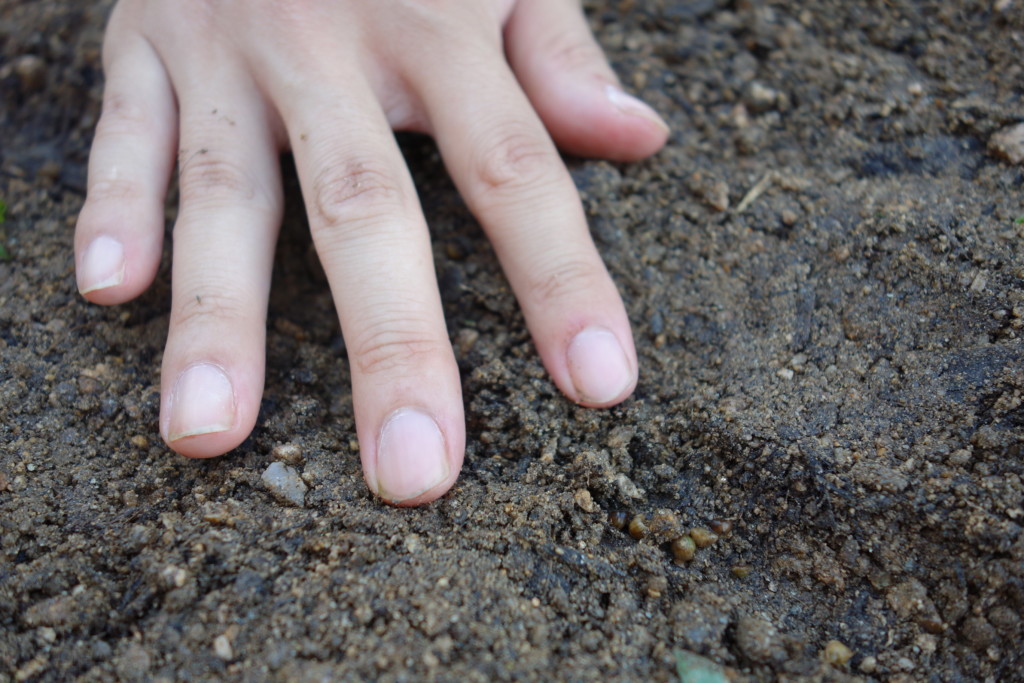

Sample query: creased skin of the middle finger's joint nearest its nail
[352,322,452,375]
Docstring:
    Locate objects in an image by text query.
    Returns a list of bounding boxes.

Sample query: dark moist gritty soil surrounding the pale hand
[0,0,1024,681]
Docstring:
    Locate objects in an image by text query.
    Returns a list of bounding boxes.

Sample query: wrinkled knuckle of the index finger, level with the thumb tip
[477,125,558,198]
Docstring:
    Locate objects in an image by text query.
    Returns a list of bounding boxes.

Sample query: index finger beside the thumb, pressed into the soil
[414,45,637,407]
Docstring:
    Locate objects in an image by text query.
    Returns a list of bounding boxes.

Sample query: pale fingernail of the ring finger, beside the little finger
[167,362,234,441]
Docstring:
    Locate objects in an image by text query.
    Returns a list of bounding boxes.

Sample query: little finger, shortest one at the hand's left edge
[75,6,177,304]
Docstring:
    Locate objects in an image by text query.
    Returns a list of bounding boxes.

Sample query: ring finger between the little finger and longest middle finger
[155,65,283,458]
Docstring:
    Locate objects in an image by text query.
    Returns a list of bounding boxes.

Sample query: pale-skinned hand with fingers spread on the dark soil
[75,0,668,505]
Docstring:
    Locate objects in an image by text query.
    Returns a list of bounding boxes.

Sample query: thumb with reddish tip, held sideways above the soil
[505,0,669,161]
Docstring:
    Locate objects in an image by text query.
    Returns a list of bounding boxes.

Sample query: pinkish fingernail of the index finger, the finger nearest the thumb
[567,327,633,403]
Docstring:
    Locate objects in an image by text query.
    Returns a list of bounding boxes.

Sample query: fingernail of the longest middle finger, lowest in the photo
[377,408,449,503]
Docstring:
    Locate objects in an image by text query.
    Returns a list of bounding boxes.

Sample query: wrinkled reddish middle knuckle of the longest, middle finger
[311,160,402,227]
